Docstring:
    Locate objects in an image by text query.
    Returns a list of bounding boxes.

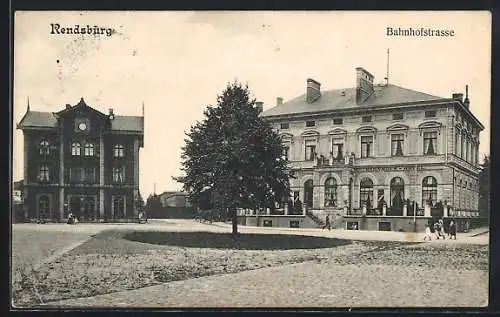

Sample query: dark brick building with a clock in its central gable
[17,98,144,221]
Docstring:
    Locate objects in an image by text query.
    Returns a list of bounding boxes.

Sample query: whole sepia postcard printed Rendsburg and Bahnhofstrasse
[11,11,492,309]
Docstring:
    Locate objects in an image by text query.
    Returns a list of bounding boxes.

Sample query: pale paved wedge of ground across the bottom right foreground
[51,246,488,307]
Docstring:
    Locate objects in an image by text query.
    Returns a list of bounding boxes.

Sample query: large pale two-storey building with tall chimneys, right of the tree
[250,67,484,231]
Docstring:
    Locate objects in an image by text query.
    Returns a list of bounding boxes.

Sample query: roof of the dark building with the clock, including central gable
[17,98,144,133]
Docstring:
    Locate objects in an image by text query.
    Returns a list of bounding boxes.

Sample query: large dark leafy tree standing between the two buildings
[175,82,292,234]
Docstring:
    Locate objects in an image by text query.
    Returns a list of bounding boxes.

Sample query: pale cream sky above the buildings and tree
[13,11,491,197]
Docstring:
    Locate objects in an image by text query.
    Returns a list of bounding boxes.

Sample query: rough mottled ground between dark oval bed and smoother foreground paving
[11,230,364,305]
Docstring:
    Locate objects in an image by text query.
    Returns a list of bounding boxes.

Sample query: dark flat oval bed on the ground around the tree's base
[124,231,351,250]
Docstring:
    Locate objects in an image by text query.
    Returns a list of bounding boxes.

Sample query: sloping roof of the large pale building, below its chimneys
[262,84,448,117]
